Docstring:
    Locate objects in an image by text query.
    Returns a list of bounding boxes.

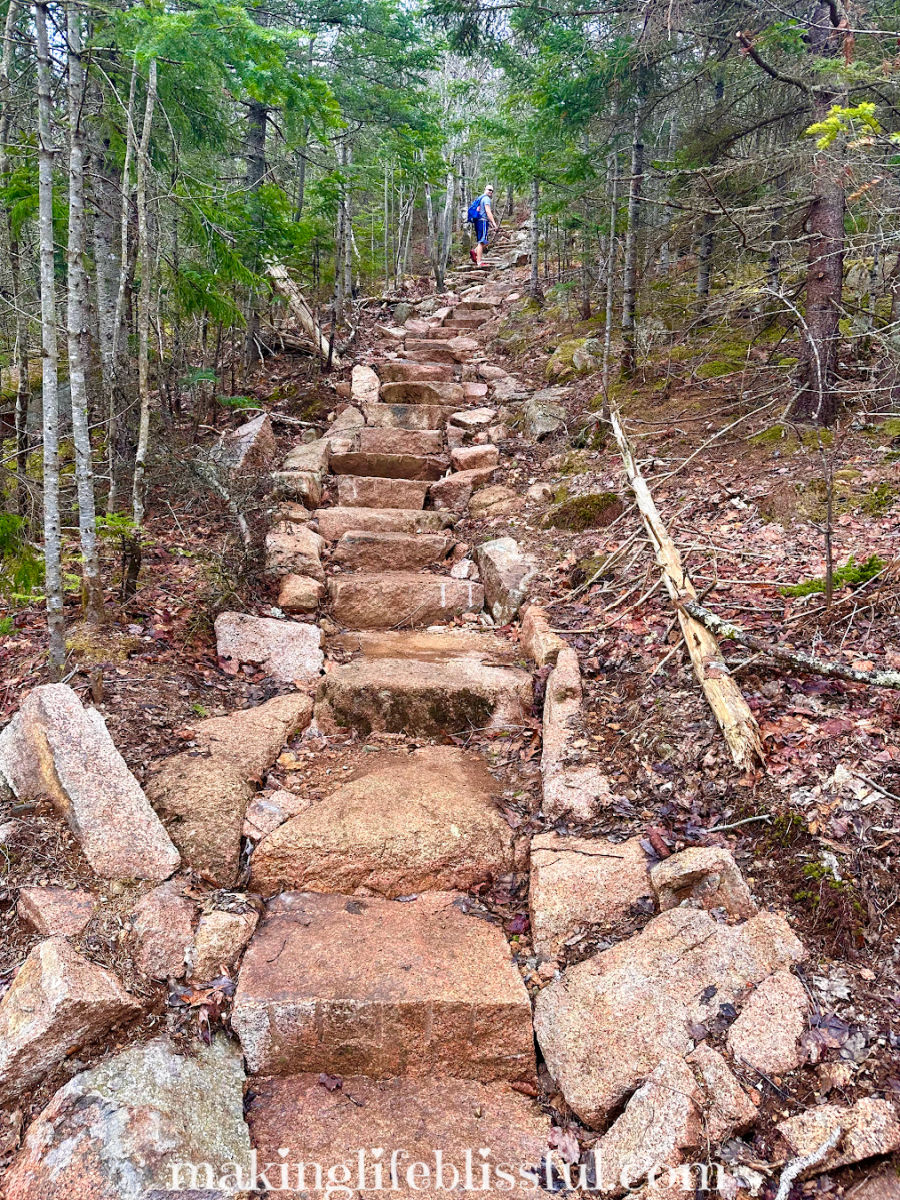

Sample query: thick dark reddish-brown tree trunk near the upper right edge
[792,4,845,425]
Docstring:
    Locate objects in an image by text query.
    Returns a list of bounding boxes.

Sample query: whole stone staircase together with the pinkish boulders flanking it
[0,246,900,1200]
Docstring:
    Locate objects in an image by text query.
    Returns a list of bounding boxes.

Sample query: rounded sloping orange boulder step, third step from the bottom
[251,746,514,898]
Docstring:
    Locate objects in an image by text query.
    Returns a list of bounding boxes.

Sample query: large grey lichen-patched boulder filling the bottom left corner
[4,1034,251,1200]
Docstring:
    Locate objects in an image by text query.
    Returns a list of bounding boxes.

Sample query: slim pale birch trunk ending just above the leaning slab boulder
[35,4,66,678]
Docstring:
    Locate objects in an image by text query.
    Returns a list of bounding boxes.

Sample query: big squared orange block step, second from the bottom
[232,892,535,1080]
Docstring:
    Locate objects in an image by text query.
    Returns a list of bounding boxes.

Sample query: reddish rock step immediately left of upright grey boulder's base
[328,571,485,629]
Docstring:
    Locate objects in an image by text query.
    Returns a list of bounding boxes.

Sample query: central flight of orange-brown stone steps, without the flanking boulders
[233,270,548,1168]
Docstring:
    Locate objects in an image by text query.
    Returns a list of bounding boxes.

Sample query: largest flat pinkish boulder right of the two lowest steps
[534,907,803,1128]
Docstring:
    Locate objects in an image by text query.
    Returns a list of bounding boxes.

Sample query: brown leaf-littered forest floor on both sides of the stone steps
[0,248,900,1176]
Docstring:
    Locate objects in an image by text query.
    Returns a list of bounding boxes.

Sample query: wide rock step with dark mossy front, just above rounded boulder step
[316,658,532,737]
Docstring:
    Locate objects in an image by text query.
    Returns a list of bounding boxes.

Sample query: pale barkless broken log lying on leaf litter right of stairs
[610,409,764,770]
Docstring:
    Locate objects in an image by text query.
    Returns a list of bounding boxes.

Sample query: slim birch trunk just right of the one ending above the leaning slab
[66,4,103,624]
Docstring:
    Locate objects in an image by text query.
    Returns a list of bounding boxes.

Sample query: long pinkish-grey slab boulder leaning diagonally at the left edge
[0,683,180,880]
